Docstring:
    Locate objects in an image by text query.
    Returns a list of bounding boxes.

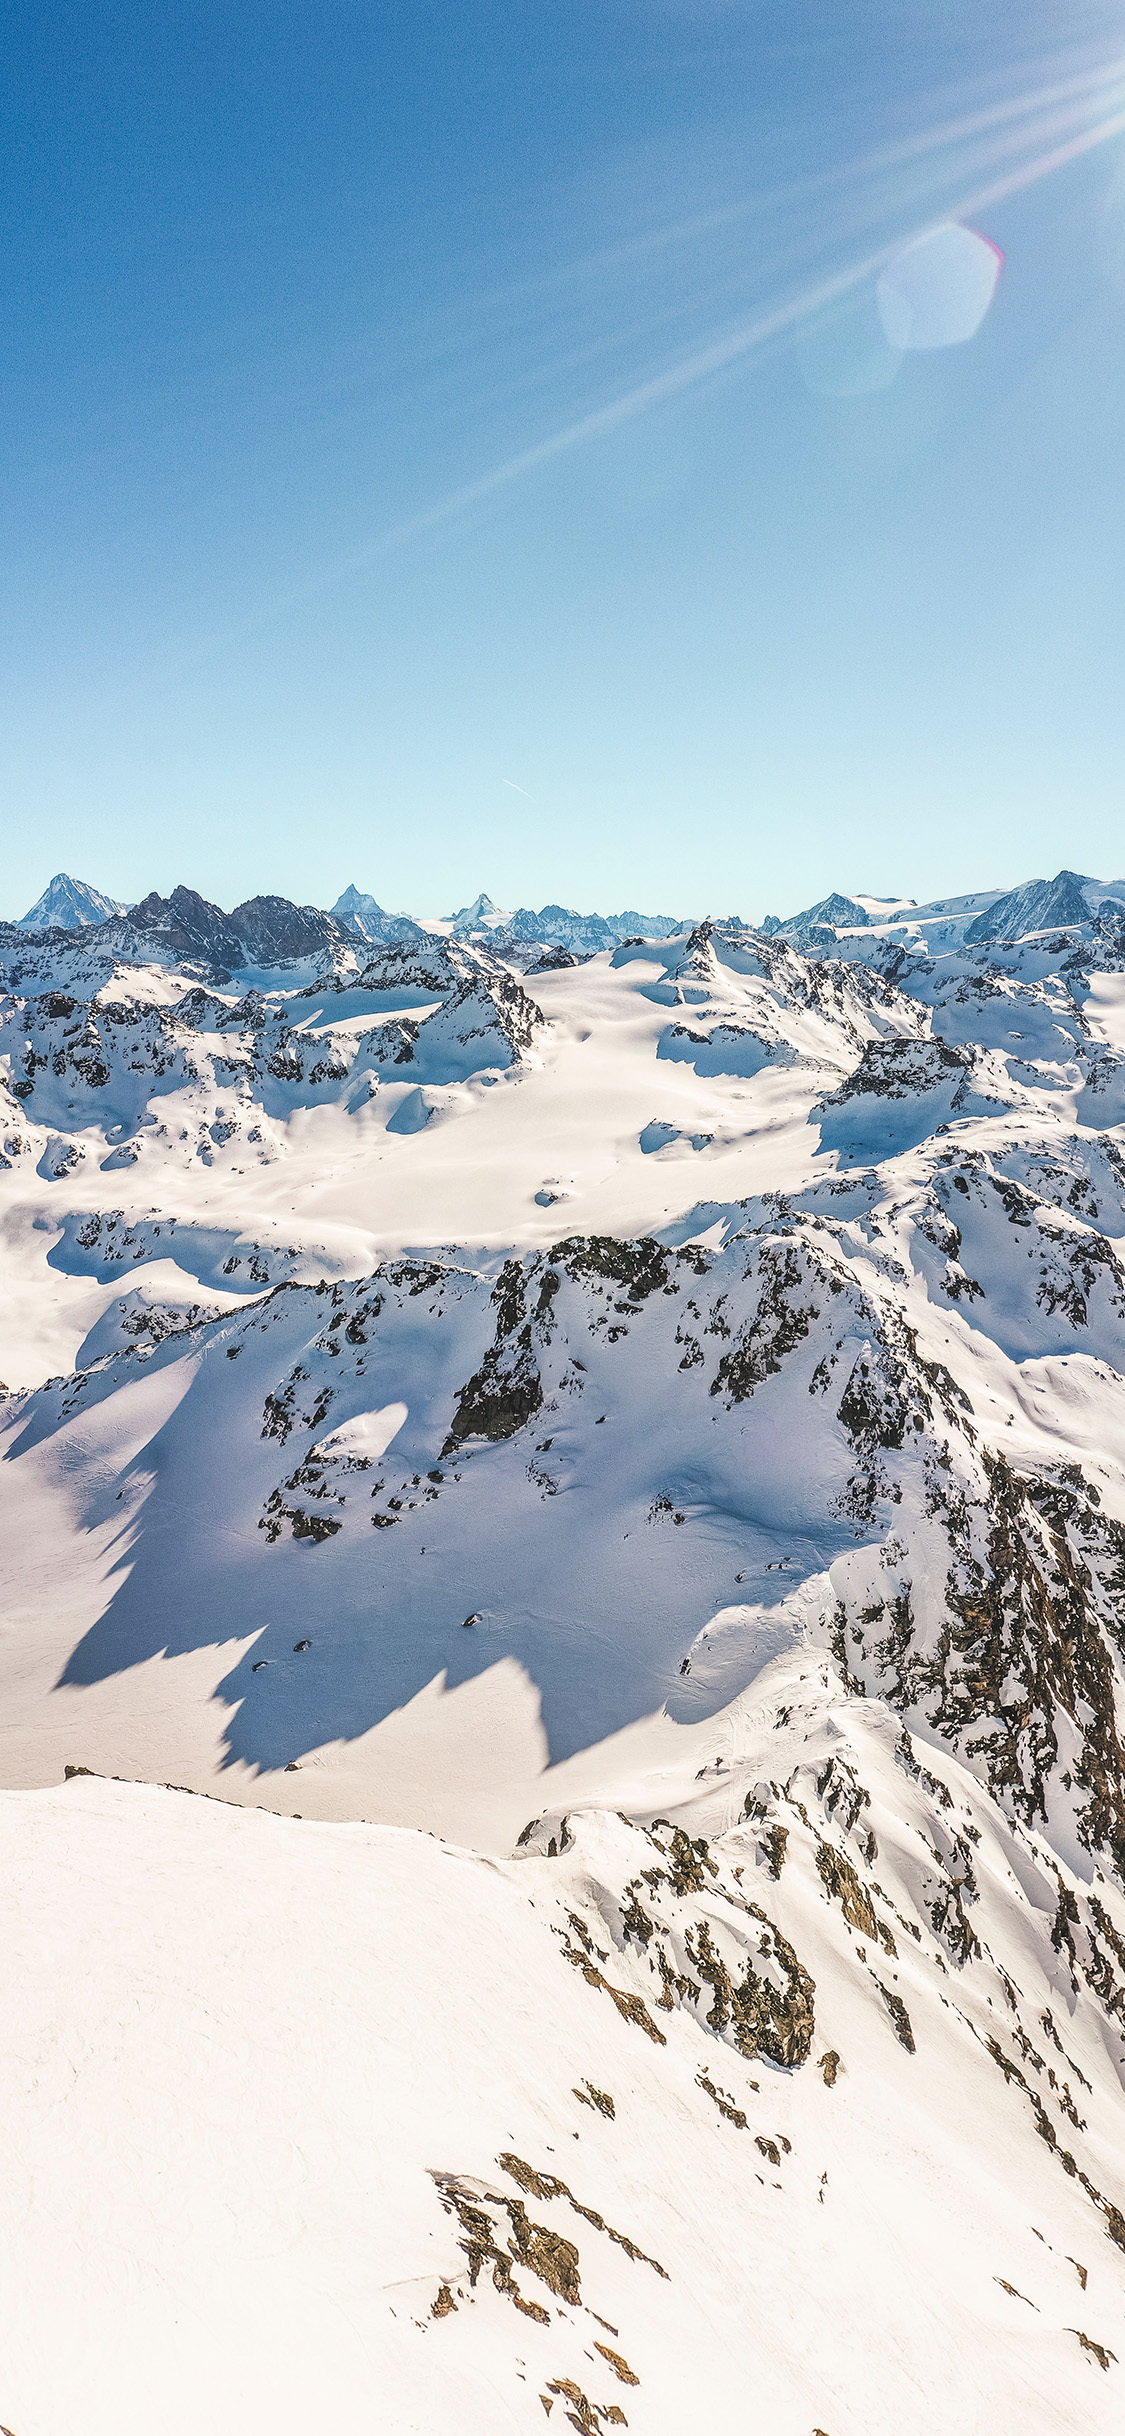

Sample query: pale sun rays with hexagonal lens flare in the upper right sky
[154,51,1125,667]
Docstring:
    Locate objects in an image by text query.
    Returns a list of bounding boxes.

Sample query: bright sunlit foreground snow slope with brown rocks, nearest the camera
[0,1714,1125,2436]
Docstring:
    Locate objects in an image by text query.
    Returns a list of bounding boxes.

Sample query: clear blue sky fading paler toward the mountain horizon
[0,0,1125,918]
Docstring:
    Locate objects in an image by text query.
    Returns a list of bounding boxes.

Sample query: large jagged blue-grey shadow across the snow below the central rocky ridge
[41,1328,855,1769]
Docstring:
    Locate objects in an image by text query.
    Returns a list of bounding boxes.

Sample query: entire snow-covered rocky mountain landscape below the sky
[0,872,1125,2436]
